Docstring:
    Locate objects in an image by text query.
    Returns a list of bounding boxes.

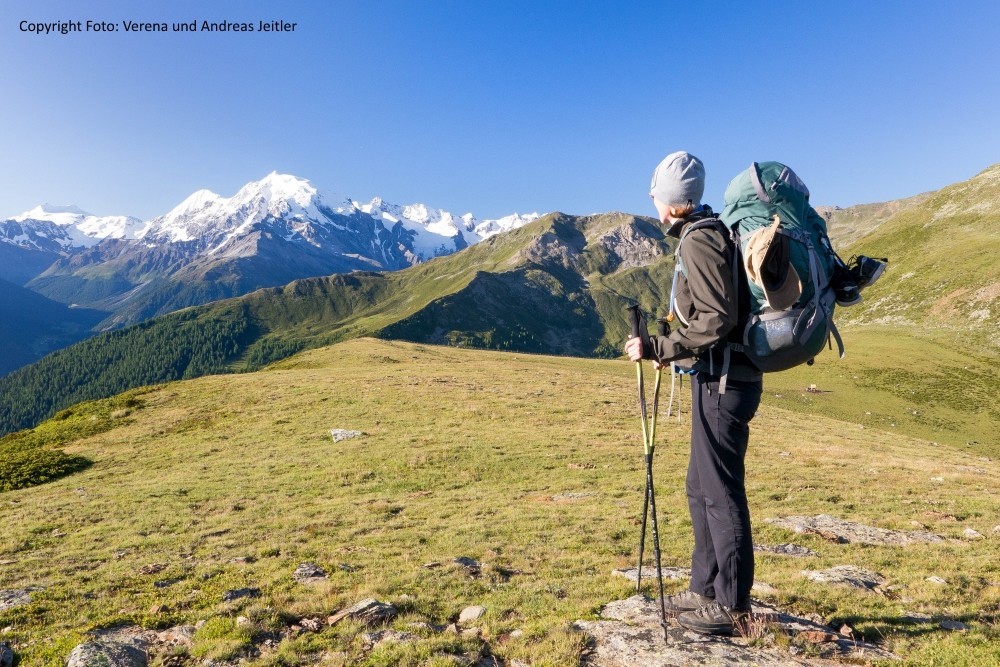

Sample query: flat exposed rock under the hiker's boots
[574,595,896,667]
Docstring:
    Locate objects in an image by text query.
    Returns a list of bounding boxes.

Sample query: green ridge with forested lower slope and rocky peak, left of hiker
[0,213,672,433]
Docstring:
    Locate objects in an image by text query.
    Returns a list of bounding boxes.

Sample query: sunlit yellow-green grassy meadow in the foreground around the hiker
[0,339,1000,666]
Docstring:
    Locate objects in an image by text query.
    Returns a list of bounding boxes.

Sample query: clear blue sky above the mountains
[0,0,1000,218]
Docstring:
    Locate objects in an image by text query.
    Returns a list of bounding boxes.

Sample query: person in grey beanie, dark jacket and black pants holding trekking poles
[625,151,762,635]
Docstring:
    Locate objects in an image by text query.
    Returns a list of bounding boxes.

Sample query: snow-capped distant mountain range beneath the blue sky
[0,173,538,374]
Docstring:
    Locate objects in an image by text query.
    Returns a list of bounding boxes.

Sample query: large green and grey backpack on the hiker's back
[720,162,844,372]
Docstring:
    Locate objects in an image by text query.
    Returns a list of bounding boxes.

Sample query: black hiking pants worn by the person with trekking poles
[687,373,762,609]
